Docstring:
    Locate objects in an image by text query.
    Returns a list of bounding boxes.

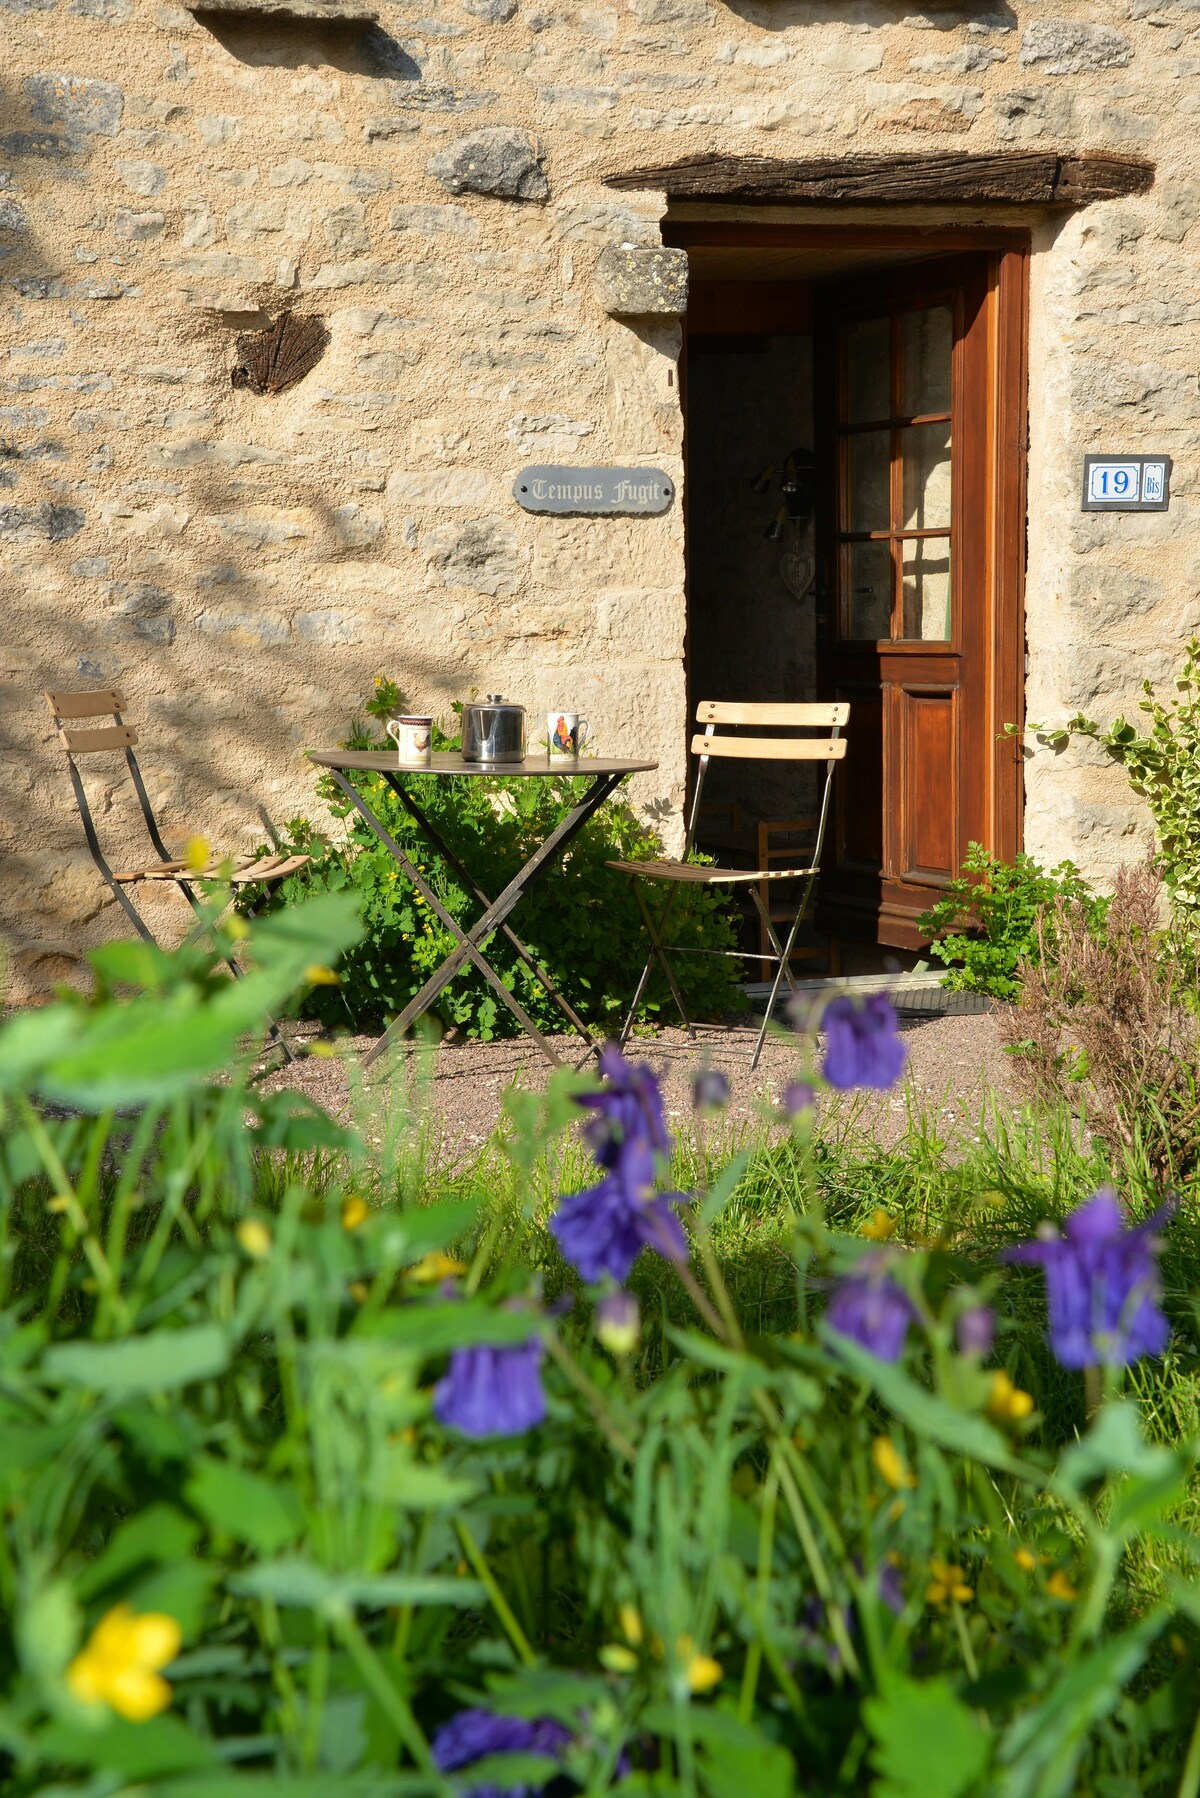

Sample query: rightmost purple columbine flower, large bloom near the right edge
[1004,1187,1171,1368]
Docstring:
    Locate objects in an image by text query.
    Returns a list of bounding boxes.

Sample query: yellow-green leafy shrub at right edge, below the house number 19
[1029,636,1200,937]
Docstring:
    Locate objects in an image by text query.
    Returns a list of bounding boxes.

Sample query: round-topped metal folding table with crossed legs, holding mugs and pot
[309,750,658,1066]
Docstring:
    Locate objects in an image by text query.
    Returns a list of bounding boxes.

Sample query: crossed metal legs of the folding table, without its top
[329,768,624,1068]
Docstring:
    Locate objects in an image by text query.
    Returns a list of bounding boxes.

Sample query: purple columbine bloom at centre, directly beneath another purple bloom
[551,1140,687,1282]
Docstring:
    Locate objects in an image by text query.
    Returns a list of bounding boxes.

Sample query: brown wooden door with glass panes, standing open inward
[815,255,993,948]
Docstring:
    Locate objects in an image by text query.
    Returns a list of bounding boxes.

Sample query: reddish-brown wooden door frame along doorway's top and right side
[676,219,1029,948]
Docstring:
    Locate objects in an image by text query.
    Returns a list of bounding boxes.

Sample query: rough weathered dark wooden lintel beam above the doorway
[604,151,1155,207]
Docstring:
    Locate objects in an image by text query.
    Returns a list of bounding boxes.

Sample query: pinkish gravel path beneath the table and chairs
[263,1014,1015,1165]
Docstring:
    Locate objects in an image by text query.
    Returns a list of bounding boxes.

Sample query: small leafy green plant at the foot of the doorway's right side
[918,843,1108,1000]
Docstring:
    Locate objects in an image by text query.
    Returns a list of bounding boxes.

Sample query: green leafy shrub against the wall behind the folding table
[253,681,739,1041]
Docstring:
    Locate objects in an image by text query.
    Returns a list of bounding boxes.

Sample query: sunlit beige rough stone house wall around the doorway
[0,0,1200,998]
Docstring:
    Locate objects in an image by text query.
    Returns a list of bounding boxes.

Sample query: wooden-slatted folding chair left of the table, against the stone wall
[45,689,311,1061]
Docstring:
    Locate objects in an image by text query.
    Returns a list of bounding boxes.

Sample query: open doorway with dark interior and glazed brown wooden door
[680,219,1027,951]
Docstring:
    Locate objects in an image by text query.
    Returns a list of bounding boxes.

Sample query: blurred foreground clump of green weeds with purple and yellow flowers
[0,927,1200,1798]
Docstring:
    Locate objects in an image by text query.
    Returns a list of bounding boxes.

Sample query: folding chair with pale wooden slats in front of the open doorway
[608,699,849,1068]
